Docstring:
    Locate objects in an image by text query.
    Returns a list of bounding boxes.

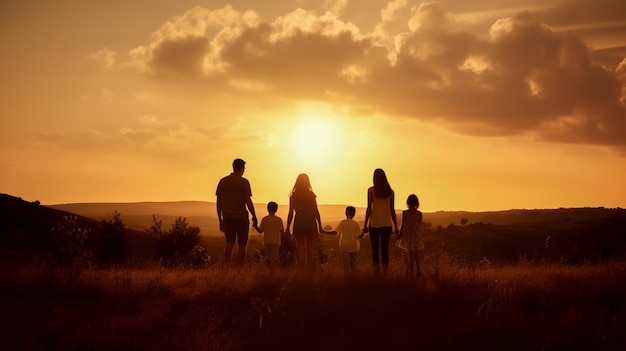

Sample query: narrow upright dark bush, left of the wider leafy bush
[93,211,126,266]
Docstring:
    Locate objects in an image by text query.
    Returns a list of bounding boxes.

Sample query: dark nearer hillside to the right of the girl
[424,214,626,263]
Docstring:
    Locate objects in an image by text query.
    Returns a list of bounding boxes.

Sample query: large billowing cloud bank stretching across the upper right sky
[127,0,626,153]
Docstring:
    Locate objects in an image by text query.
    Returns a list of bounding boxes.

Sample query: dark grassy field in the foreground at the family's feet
[0,251,626,350]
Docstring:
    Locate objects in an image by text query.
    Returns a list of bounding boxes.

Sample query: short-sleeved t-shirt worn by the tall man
[215,173,252,218]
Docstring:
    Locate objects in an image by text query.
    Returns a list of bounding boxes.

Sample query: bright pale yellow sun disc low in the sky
[291,117,337,161]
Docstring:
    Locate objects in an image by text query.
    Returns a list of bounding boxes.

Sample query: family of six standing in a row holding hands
[216,158,424,277]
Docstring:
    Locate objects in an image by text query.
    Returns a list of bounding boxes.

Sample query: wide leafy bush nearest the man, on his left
[148,216,201,267]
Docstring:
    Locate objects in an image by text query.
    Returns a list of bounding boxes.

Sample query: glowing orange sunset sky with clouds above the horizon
[0,0,626,211]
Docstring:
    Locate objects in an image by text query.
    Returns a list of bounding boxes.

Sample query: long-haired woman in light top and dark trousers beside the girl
[363,168,399,277]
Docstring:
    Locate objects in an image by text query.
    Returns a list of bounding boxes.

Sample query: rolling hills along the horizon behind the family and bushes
[0,194,626,263]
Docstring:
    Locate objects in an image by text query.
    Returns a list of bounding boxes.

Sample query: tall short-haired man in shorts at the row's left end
[215,158,257,264]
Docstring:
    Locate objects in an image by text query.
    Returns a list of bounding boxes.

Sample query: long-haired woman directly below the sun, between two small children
[286,173,325,271]
